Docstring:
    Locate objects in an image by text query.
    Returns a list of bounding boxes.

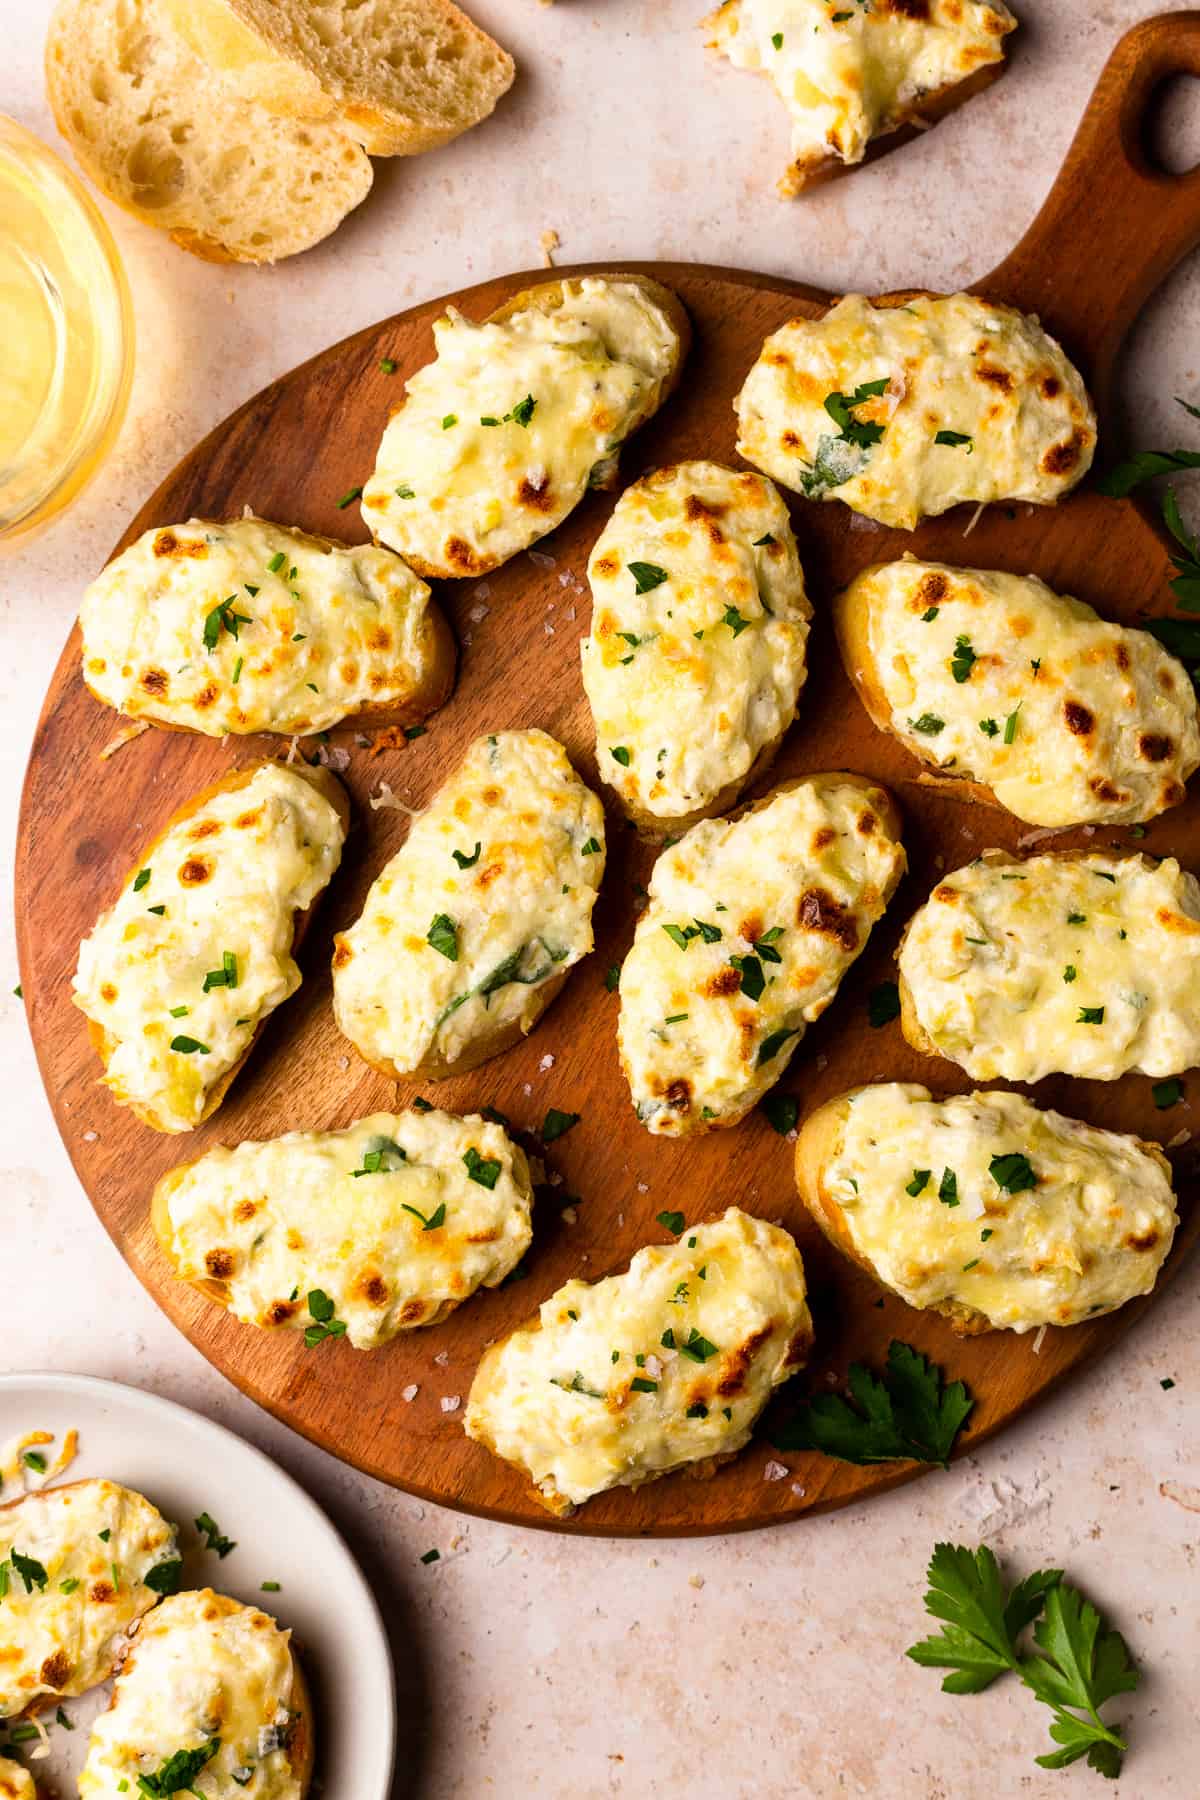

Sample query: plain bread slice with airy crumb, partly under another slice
[45,0,371,263]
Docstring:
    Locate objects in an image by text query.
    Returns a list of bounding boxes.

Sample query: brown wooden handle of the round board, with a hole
[981,13,1200,421]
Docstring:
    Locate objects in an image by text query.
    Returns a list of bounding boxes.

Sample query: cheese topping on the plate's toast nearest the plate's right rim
[79,1588,300,1800]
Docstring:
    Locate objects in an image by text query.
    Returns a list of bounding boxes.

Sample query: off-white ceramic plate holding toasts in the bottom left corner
[0,1375,396,1800]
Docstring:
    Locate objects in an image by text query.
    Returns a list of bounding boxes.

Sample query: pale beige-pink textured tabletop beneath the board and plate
[0,0,1200,1800]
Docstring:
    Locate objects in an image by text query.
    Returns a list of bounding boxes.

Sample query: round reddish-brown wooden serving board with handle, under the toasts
[16,13,1200,1535]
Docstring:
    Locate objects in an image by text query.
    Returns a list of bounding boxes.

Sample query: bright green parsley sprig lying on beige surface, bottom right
[907,1544,1141,1778]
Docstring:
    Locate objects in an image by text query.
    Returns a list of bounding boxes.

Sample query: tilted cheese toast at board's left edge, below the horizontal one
[72,761,349,1132]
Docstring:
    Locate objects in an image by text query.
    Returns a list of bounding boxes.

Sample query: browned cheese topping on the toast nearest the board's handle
[734,293,1096,529]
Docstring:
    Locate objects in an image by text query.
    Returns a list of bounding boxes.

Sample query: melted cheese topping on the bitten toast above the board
[705,0,1016,194]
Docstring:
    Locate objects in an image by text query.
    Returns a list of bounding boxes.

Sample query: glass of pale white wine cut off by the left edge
[0,113,133,549]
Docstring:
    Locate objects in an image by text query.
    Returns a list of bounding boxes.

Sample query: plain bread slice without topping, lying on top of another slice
[166,0,515,157]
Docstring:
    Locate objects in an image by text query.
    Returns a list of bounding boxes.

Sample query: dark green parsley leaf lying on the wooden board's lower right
[770,1337,975,1467]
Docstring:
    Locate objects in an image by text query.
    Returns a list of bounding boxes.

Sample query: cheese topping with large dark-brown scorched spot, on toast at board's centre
[619,778,905,1136]
